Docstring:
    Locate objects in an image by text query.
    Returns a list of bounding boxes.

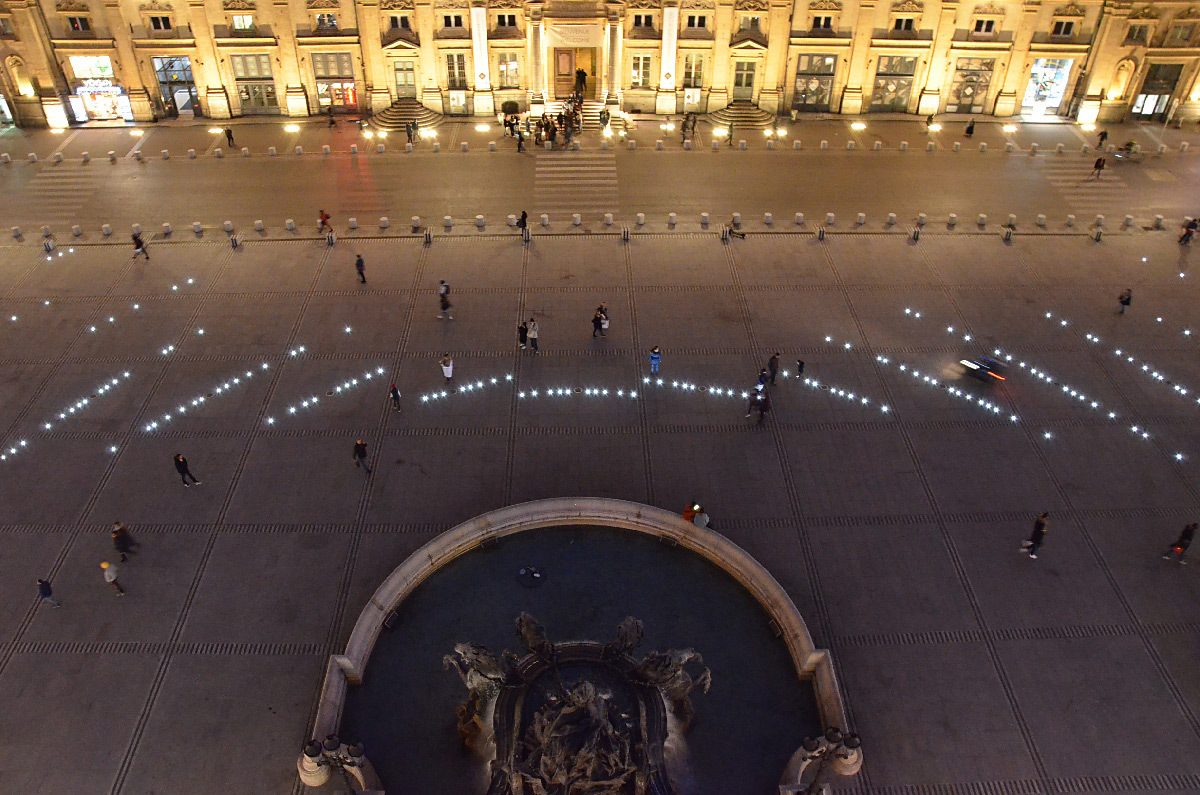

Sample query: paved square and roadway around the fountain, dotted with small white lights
[0,130,1200,794]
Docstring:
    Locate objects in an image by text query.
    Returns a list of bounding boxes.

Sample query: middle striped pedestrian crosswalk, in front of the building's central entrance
[534,151,618,217]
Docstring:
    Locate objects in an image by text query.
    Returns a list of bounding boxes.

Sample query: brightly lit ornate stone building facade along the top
[0,0,1200,126]
